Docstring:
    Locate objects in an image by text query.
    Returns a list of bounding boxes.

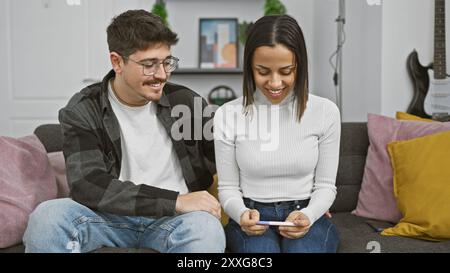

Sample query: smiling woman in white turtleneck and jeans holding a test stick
[214,15,340,252]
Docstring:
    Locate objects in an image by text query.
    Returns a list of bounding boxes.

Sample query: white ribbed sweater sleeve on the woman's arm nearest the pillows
[301,101,341,225]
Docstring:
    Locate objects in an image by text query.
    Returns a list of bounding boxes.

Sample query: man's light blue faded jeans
[23,198,225,253]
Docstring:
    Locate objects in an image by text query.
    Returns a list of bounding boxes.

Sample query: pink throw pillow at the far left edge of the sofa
[0,135,58,248]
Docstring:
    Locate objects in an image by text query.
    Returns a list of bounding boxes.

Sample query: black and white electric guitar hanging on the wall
[407,0,450,117]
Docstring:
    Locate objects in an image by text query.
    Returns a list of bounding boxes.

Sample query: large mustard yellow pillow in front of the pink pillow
[381,131,450,241]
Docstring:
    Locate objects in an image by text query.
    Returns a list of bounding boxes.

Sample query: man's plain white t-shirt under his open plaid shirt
[108,82,188,194]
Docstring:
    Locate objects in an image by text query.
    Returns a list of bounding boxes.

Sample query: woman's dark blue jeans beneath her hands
[225,198,339,253]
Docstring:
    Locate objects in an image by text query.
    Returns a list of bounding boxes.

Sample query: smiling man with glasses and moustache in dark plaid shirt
[24,10,225,252]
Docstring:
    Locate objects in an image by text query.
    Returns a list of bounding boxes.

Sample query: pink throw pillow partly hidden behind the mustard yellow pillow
[352,114,450,223]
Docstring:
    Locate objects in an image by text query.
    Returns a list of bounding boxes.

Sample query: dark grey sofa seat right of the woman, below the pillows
[330,212,450,253]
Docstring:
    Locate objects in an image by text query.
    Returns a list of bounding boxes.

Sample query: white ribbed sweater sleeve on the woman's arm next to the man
[214,105,247,224]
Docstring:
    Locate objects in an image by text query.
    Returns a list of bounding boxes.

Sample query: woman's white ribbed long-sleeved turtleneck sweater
[214,90,341,224]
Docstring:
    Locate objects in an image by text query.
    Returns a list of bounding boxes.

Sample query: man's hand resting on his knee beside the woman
[175,191,222,220]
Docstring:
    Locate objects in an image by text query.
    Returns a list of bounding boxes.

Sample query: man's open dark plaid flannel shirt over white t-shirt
[59,71,215,218]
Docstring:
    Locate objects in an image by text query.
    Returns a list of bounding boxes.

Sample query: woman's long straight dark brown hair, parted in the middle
[243,15,309,121]
